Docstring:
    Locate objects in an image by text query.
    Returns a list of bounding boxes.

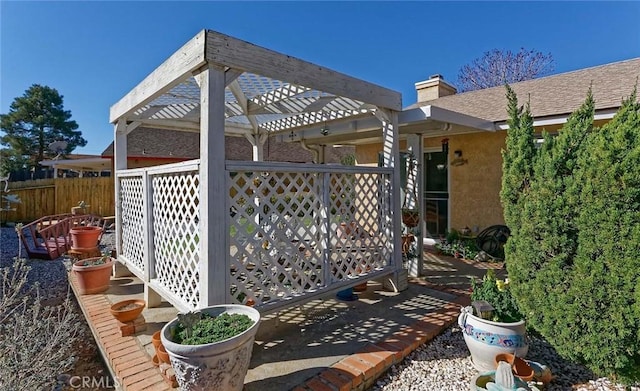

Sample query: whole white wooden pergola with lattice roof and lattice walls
[110,30,406,311]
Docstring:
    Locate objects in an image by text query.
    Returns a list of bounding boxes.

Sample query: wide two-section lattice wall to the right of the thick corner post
[229,167,392,305]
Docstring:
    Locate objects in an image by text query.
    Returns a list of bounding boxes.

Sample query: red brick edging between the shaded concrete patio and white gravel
[293,279,471,391]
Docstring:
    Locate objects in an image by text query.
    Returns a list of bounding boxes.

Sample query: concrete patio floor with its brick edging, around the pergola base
[70,251,501,391]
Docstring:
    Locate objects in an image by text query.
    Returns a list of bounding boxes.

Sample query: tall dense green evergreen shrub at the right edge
[500,87,640,381]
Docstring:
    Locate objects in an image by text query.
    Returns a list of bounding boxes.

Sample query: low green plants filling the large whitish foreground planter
[172,311,254,345]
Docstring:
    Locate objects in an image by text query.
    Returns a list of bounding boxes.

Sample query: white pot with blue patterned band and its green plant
[458,270,529,371]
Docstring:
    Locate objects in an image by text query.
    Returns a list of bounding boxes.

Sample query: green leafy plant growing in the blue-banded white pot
[471,269,524,323]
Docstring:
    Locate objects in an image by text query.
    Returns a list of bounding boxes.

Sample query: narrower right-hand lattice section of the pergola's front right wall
[329,173,393,281]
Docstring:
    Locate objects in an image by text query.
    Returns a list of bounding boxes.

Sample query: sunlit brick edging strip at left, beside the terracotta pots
[69,272,173,391]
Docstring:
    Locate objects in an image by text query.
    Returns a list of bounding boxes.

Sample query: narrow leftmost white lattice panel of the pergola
[120,177,145,271]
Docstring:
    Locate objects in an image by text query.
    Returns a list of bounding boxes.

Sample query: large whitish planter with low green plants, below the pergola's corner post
[160,304,260,391]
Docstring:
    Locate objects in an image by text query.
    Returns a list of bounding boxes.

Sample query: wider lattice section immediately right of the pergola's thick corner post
[229,172,325,305]
